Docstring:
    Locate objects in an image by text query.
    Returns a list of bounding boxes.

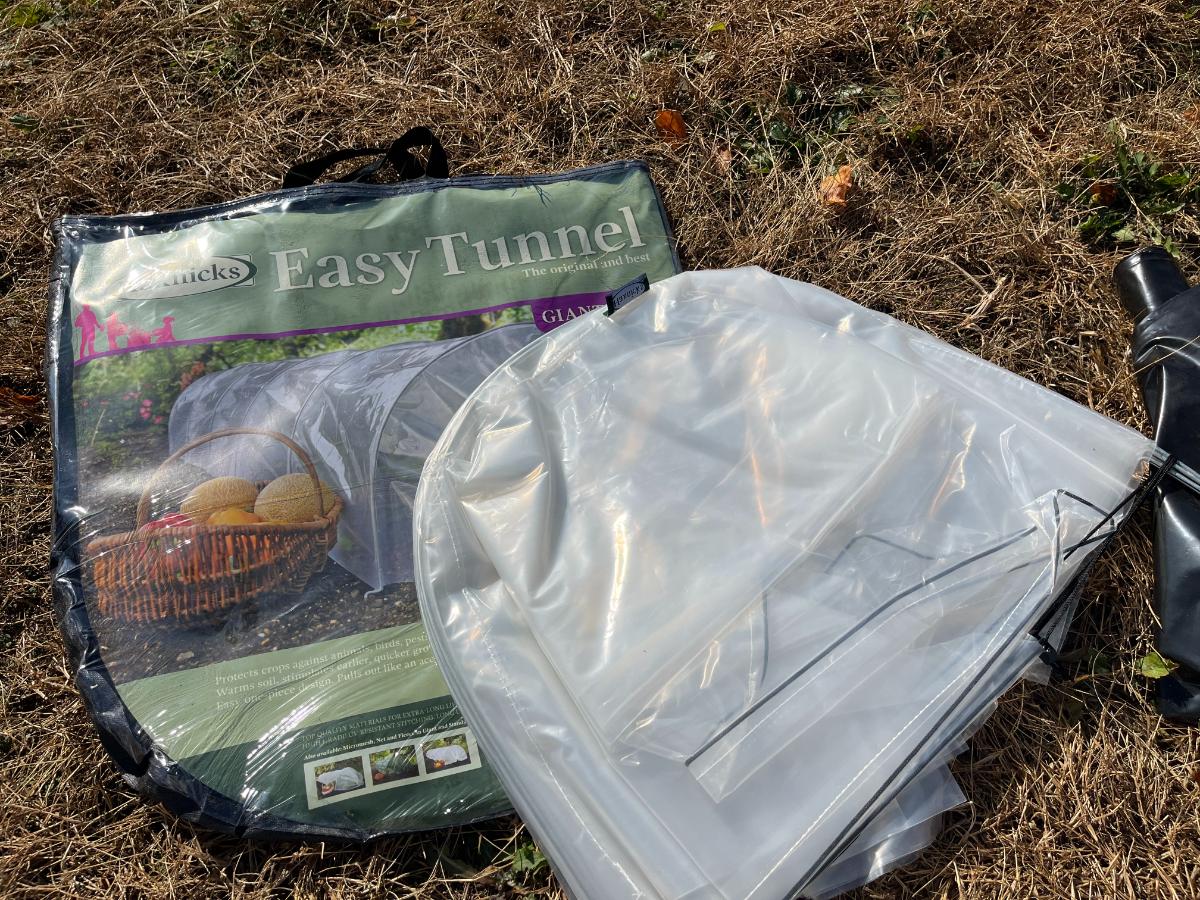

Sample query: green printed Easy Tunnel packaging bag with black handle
[48,130,678,839]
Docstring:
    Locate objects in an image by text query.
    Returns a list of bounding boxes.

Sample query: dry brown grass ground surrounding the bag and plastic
[0,0,1200,900]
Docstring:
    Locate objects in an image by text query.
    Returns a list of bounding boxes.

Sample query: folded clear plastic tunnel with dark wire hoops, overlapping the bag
[414,269,1152,900]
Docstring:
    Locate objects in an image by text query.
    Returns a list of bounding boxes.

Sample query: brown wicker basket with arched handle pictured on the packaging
[88,428,342,622]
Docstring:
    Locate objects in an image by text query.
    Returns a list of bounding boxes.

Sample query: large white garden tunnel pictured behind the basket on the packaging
[169,324,539,589]
